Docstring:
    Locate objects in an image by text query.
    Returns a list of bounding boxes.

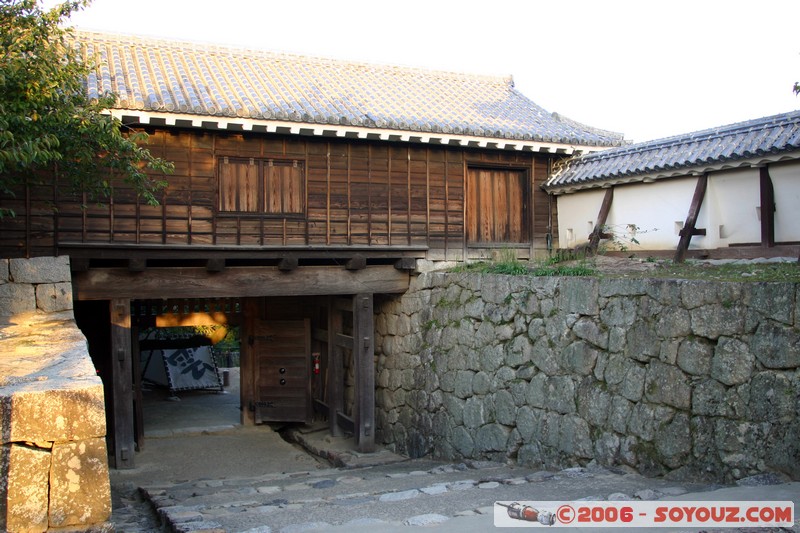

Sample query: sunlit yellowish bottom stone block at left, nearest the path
[49,438,111,527]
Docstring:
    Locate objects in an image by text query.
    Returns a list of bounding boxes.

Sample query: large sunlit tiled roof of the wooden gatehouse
[76,32,623,152]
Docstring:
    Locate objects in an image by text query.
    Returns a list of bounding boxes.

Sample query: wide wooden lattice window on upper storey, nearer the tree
[219,157,305,216]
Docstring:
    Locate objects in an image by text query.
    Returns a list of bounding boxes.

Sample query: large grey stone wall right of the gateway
[376,273,800,481]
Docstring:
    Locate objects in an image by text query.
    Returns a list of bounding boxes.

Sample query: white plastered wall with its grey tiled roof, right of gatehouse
[545,111,800,260]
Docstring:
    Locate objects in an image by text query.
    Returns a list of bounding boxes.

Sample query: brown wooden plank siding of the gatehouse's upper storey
[0,128,557,260]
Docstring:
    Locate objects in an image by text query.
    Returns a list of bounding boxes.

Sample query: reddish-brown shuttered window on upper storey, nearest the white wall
[467,167,530,246]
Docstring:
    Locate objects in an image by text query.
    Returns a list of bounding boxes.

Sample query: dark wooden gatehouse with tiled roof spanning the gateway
[0,33,622,468]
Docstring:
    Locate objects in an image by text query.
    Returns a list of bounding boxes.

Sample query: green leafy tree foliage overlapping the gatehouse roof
[0,0,173,216]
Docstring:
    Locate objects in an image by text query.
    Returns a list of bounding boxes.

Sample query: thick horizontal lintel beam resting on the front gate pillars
[73,265,409,300]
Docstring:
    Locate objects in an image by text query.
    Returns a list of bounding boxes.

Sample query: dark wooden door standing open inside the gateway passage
[253,319,311,424]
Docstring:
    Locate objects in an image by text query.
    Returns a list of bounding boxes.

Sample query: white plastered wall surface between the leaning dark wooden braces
[558,162,800,251]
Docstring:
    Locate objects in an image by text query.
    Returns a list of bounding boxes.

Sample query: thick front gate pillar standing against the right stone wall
[353,293,375,452]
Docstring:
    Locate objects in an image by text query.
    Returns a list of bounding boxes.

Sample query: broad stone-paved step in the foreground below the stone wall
[141,460,712,533]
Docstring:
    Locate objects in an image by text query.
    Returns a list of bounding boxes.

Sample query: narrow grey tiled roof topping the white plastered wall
[545,111,800,192]
